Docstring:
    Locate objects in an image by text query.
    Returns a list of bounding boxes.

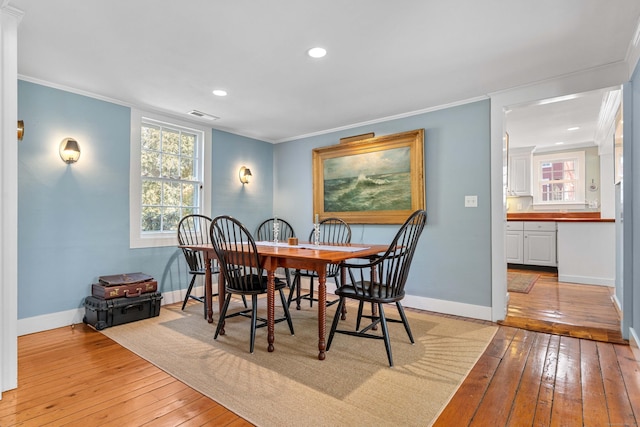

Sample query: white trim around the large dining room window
[129,108,211,249]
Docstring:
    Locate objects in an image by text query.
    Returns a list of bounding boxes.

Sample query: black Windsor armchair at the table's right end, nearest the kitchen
[327,210,427,367]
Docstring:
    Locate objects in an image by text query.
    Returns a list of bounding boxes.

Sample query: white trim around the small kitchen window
[533,151,586,210]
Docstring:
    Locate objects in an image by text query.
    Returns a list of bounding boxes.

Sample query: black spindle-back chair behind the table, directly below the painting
[288,218,351,310]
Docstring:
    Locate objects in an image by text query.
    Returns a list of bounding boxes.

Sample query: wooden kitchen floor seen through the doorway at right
[500,268,627,343]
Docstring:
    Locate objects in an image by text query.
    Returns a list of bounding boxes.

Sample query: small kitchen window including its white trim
[533,151,585,207]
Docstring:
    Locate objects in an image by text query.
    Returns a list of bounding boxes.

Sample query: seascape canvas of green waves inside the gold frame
[324,147,411,212]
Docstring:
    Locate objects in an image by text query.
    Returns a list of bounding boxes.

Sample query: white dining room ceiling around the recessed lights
[8,0,640,142]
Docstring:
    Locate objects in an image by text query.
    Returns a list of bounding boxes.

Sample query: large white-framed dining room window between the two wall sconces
[130,111,210,248]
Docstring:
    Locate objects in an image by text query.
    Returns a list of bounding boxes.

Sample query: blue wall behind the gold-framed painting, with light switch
[274,100,491,307]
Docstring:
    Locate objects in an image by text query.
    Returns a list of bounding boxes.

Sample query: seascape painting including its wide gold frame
[313,129,425,224]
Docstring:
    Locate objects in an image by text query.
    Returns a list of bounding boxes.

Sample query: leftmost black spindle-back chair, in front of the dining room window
[178,214,219,317]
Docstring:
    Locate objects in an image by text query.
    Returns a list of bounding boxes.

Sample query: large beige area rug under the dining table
[102,300,497,426]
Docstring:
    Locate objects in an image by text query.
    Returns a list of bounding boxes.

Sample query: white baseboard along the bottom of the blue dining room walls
[18,280,490,338]
